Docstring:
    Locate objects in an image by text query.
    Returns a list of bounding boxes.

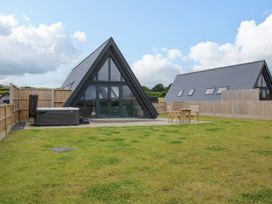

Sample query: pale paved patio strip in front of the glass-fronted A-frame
[25,118,210,129]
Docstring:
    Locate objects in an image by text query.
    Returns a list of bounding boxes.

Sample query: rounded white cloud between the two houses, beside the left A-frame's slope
[131,49,183,87]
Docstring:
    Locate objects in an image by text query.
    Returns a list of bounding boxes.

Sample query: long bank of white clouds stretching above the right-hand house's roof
[132,14,272,86]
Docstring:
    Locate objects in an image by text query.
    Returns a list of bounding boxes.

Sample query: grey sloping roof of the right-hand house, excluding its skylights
[165,60,267,101]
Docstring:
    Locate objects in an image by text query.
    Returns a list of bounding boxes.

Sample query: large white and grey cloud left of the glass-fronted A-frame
[0,15,86,79]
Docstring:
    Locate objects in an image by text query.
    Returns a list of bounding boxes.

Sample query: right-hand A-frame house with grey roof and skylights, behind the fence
[165,60,272,102]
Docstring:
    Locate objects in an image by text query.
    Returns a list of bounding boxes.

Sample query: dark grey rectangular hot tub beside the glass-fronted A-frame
[35,107,79,126]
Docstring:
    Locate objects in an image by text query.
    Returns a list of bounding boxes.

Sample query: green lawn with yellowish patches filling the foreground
[0,118,272,204]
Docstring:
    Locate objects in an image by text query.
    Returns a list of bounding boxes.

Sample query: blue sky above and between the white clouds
[0,0,272,86]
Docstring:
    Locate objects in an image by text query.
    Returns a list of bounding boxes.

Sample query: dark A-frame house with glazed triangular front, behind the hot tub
[62,38,158,118]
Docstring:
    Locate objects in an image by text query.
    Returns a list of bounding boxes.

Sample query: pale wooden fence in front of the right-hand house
[158,89,272,119]
